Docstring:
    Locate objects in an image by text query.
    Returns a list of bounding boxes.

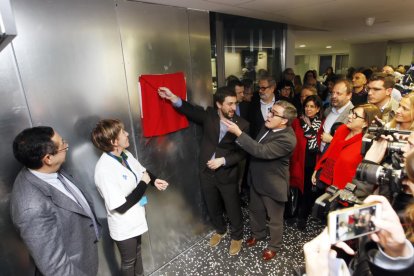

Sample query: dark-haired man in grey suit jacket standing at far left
[10,127,100,276]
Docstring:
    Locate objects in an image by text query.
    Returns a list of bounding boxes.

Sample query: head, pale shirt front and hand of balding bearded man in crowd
[320,79,354,152]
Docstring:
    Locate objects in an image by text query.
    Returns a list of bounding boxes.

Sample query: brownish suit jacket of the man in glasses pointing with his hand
[236,127,296,202]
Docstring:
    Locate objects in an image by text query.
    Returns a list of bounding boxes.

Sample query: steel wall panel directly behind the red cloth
[117,1,211,272]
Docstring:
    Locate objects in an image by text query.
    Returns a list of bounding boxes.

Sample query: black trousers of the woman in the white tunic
[115,236,144,276]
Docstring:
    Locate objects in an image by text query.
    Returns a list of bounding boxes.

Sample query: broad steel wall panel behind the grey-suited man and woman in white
[13,0,135,275]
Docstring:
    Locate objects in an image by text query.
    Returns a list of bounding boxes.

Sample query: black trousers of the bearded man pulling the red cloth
[200,170,243,240]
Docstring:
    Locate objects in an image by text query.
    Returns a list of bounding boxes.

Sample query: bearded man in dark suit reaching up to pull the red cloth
[158,87,249,255]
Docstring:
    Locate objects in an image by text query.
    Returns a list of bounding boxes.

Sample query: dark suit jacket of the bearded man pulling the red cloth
[177,101,249,184]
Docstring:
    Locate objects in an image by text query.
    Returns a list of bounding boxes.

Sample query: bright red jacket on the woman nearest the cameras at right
[315,125,363,189]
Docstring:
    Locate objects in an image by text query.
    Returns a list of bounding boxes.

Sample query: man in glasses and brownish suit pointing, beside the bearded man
[225,101,297,261]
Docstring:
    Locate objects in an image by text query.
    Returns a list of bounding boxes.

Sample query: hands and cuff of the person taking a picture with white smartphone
[303,195,414,276]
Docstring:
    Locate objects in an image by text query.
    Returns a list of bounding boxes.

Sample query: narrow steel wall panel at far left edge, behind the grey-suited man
[0,44,31,275]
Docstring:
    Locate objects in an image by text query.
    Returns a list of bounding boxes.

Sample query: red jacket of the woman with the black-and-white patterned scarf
[289,118,323,194]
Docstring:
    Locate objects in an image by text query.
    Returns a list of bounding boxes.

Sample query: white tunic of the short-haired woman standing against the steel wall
[95,151,148,241]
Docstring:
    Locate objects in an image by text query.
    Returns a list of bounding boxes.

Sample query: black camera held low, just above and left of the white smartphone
[312,183,362,220]
